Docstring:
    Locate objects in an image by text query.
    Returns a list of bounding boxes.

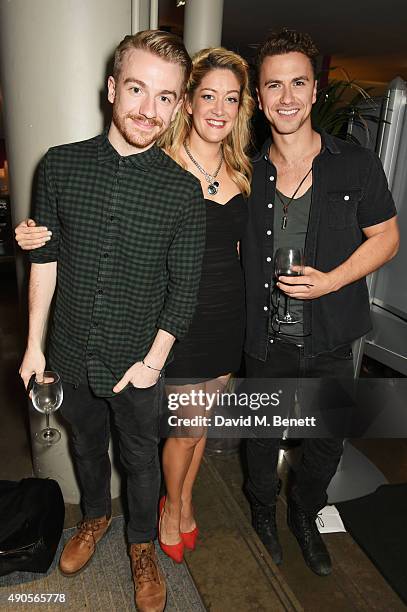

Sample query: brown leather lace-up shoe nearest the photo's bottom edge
[130,542,167,612]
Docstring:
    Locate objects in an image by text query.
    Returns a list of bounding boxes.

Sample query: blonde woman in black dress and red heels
[159,48,253,561]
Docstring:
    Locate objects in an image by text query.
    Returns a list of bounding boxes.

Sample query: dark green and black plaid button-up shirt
[30,133,205,397]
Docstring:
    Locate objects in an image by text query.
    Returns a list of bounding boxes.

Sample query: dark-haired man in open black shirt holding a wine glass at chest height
[242,30,399,576]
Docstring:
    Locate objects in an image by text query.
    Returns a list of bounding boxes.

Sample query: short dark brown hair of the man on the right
[256,28,319,78]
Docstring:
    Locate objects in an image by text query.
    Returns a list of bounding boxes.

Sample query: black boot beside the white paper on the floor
[287,500,332,576]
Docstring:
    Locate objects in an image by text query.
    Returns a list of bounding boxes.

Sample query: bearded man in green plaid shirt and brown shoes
[20,31,205,610]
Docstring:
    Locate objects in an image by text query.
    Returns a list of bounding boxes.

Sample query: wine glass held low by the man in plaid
[31,371,64,446]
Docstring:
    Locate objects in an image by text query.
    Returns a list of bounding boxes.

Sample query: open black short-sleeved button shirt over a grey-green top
[242,133,396,361]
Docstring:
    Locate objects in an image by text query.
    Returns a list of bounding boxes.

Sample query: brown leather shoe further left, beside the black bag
[59,516,112,576]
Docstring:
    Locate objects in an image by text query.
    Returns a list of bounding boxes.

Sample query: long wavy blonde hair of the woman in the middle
[157,47,254,197]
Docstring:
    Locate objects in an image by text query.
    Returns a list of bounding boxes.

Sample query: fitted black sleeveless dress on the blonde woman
[165,194,247,384]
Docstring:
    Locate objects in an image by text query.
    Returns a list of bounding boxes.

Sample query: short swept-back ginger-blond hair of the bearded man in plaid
[113,30,192,91]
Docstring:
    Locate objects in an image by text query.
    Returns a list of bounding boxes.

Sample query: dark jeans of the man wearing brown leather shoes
[61,379,164,544]
